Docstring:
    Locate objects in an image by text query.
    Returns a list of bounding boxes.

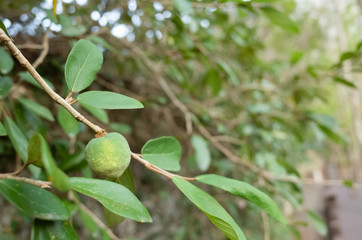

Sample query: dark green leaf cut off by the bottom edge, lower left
[31,219,79,240]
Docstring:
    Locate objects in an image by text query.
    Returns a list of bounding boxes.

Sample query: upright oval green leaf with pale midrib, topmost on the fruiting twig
[65,39,103,92]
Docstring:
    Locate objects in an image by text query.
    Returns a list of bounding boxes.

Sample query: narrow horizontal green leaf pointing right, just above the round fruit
[77,91,143,109]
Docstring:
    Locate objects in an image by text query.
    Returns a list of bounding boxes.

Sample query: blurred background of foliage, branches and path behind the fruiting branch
[0,0,362,240]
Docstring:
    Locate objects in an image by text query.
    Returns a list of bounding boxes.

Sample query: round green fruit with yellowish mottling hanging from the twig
[85,133,131,178]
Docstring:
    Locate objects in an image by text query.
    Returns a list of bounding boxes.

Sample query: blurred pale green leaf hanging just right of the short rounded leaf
[191,134,211,172]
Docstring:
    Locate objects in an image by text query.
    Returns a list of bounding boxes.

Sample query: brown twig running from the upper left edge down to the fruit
[0,29,105,136]
